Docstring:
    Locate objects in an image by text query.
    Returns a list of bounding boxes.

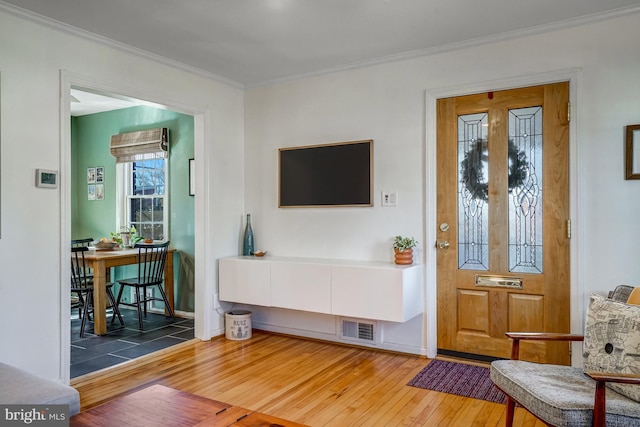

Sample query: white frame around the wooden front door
[423,68,585,366]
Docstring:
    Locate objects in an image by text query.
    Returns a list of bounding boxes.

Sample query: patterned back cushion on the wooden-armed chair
[583,295,640,402]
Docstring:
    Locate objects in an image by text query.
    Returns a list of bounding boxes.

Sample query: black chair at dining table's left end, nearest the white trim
[71,246,124,337]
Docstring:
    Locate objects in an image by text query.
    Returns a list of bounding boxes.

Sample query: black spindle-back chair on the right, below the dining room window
[111,241,175,331]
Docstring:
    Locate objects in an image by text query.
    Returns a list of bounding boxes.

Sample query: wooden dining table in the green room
[85,247,176,335]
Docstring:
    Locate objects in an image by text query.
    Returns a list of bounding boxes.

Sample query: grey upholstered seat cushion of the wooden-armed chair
[491,360,640,427]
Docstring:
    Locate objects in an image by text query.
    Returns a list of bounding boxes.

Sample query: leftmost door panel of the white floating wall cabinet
[218,259,271,307]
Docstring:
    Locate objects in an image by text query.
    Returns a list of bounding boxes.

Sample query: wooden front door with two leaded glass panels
[436,83,570,364]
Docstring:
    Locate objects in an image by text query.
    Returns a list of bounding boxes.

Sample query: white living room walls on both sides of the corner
[5,5,640,381]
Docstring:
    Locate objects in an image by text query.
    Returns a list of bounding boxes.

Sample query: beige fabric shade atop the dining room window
[110,128,169,163]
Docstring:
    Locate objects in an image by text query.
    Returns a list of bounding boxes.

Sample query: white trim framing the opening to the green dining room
[59,70,211,384]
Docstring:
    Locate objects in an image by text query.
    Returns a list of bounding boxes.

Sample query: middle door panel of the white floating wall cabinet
[271,262,331,314]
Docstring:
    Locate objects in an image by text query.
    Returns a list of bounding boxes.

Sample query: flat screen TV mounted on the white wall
[278,140,373,208]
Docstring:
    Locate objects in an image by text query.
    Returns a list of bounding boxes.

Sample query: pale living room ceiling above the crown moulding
[0,0,640,113]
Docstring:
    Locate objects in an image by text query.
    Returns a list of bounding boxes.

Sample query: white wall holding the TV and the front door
[245,14,640,351]
